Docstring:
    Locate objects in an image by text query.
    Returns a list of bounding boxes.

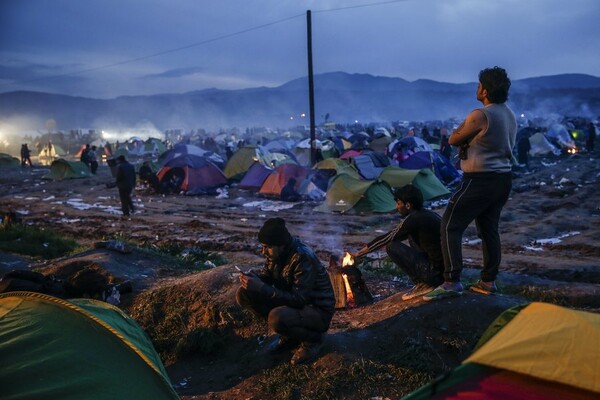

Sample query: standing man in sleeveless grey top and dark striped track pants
[423,67,517,300]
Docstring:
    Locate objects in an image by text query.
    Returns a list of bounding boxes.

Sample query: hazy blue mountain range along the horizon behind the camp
[0,72,600,130]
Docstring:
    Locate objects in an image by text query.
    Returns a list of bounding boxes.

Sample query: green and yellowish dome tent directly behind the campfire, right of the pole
[315,174,396,213]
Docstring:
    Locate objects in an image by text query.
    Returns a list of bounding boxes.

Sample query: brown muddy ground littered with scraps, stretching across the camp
[0,154,600,399]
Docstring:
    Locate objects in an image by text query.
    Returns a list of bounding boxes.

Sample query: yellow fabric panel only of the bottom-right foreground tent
[465,303,600,393]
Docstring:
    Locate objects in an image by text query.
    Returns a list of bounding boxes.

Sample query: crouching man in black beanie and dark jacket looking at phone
[236,218,335,365]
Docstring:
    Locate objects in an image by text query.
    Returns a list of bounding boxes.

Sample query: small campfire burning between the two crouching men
[328,253,373,308]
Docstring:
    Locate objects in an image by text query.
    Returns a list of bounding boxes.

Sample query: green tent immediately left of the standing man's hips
[379,166,450,200]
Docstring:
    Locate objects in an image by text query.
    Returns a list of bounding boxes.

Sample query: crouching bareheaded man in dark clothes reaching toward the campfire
[351,185,444,300]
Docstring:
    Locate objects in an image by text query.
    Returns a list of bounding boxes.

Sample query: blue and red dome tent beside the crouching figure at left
[156,154,228,195]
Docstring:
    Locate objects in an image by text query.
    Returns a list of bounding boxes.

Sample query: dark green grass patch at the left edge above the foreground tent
[0,224,79,260]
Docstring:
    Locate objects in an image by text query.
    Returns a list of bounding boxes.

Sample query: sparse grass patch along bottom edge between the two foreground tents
[259,358,432,400]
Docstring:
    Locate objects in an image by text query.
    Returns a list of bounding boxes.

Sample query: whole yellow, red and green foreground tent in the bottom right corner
[404,303,600,400]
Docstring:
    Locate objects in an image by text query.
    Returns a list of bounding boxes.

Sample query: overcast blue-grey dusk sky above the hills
[0,0,600,98]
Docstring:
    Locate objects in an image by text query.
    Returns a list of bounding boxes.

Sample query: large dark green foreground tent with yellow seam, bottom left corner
[0,292,179,400]
